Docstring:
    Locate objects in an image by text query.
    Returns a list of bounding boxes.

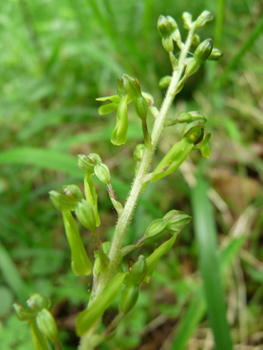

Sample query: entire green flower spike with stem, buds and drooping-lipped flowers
[14,11,222,350]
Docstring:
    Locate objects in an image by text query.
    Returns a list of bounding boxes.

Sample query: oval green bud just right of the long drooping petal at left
[75,199,96,232]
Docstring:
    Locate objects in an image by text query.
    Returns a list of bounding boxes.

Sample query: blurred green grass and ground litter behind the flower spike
[0,0,263,350]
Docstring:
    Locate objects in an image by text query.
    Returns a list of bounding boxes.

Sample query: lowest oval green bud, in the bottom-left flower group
[36,308,58,343]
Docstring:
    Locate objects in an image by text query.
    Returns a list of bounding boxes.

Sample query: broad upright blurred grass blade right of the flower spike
[191,167,232,350]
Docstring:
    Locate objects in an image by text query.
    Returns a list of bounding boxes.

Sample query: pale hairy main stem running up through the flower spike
[79,22,196,350]
